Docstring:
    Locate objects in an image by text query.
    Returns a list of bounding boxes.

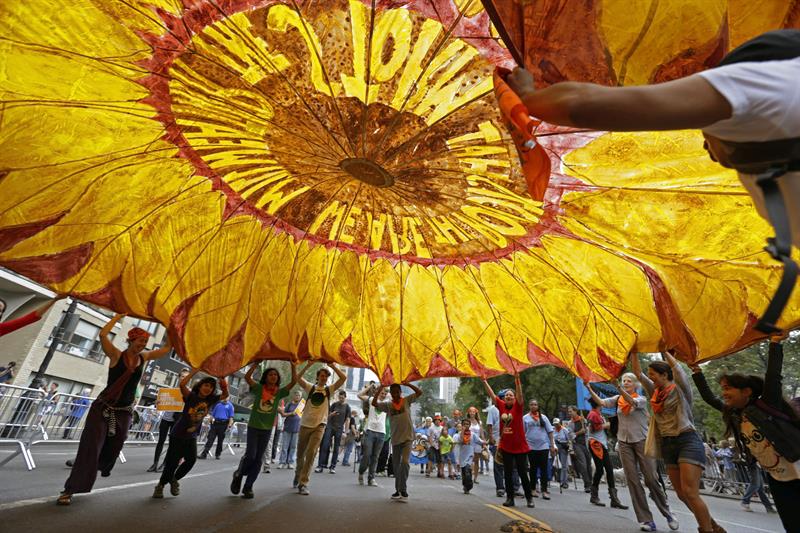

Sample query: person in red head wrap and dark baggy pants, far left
[58,313,172,505]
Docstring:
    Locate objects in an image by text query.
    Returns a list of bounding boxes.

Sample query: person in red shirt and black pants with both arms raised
[483,374,534,507]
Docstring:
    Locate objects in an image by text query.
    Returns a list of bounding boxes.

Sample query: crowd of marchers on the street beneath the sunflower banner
[1,304,800,533]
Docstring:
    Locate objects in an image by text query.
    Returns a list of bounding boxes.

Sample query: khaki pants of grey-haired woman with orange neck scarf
[619,441,670,522]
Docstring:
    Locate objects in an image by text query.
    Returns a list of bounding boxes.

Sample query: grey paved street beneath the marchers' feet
[0,444,781,533]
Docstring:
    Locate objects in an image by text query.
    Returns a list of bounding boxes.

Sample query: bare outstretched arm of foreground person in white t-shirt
[507,68,733,131]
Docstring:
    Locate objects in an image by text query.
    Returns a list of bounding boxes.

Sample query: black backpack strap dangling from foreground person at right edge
[755,165,799,334]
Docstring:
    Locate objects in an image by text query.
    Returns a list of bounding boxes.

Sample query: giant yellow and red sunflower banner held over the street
[0,0,800,381]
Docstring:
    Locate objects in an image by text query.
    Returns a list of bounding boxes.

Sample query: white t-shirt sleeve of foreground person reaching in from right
[697,57,800,142]
